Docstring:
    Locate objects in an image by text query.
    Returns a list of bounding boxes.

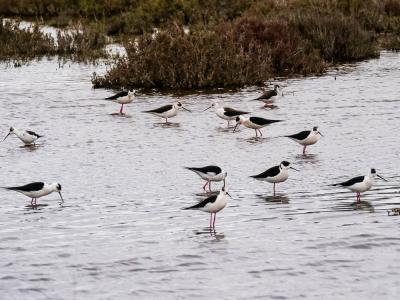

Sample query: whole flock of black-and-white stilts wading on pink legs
[3,85,386,228]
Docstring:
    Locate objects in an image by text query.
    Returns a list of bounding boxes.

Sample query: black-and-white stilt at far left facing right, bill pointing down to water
[3,182,64,206]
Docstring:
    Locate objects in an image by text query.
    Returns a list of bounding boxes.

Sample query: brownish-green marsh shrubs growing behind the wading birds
[0,0,400,88]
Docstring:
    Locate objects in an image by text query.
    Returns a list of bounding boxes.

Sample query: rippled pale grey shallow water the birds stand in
[0,52,400,300]
